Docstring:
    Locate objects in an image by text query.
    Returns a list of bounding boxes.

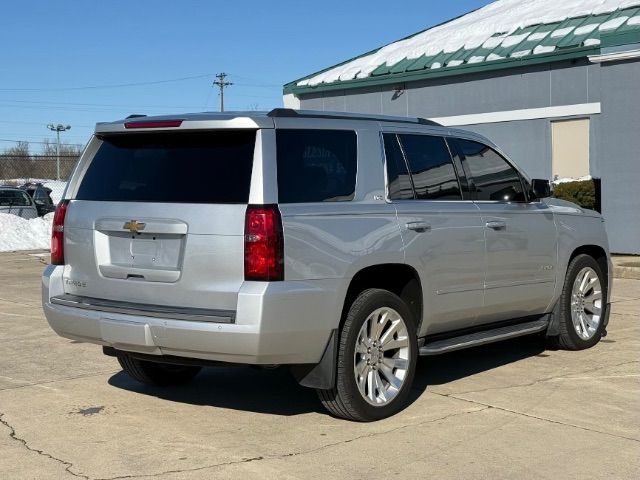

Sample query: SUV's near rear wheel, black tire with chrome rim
[316,288,418,422]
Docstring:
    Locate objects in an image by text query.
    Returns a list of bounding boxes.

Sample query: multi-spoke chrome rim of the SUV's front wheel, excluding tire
[571,267,602,340]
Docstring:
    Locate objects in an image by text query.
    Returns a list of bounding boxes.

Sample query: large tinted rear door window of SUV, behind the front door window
[399,135,462,200]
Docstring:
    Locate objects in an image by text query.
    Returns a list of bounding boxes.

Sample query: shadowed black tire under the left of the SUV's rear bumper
[117,352,201,386]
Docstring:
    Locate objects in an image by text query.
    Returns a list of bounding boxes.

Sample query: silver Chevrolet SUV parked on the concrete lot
[43,109,611,421]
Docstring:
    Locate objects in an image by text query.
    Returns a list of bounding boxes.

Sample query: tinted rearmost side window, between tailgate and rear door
[276,130,357,203]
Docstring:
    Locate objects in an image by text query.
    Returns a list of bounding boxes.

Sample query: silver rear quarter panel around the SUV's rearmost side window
[278,124,404,326]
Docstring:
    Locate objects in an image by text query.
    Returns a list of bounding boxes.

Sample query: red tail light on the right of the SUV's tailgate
[244,205,284,282]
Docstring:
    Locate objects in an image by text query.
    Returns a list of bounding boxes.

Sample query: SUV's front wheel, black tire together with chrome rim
[549,254,608,350]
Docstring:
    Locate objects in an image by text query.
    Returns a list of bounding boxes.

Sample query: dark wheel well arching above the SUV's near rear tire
[340,263,422,331]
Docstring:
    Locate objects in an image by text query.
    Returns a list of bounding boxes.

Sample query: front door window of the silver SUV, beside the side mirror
[458,140,525,202]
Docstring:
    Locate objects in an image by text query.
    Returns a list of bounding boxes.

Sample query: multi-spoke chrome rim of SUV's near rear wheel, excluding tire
[353,307,411,407]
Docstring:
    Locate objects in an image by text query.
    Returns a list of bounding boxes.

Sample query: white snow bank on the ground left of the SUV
[0,213,53,252]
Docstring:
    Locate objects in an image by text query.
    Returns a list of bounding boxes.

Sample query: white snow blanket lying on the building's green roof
[298,0,640,86]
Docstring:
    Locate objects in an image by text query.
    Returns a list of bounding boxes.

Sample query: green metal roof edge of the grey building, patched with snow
[284,7,640,95]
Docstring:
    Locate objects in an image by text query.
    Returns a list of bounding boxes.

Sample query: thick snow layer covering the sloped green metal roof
[297,0,640,87]
